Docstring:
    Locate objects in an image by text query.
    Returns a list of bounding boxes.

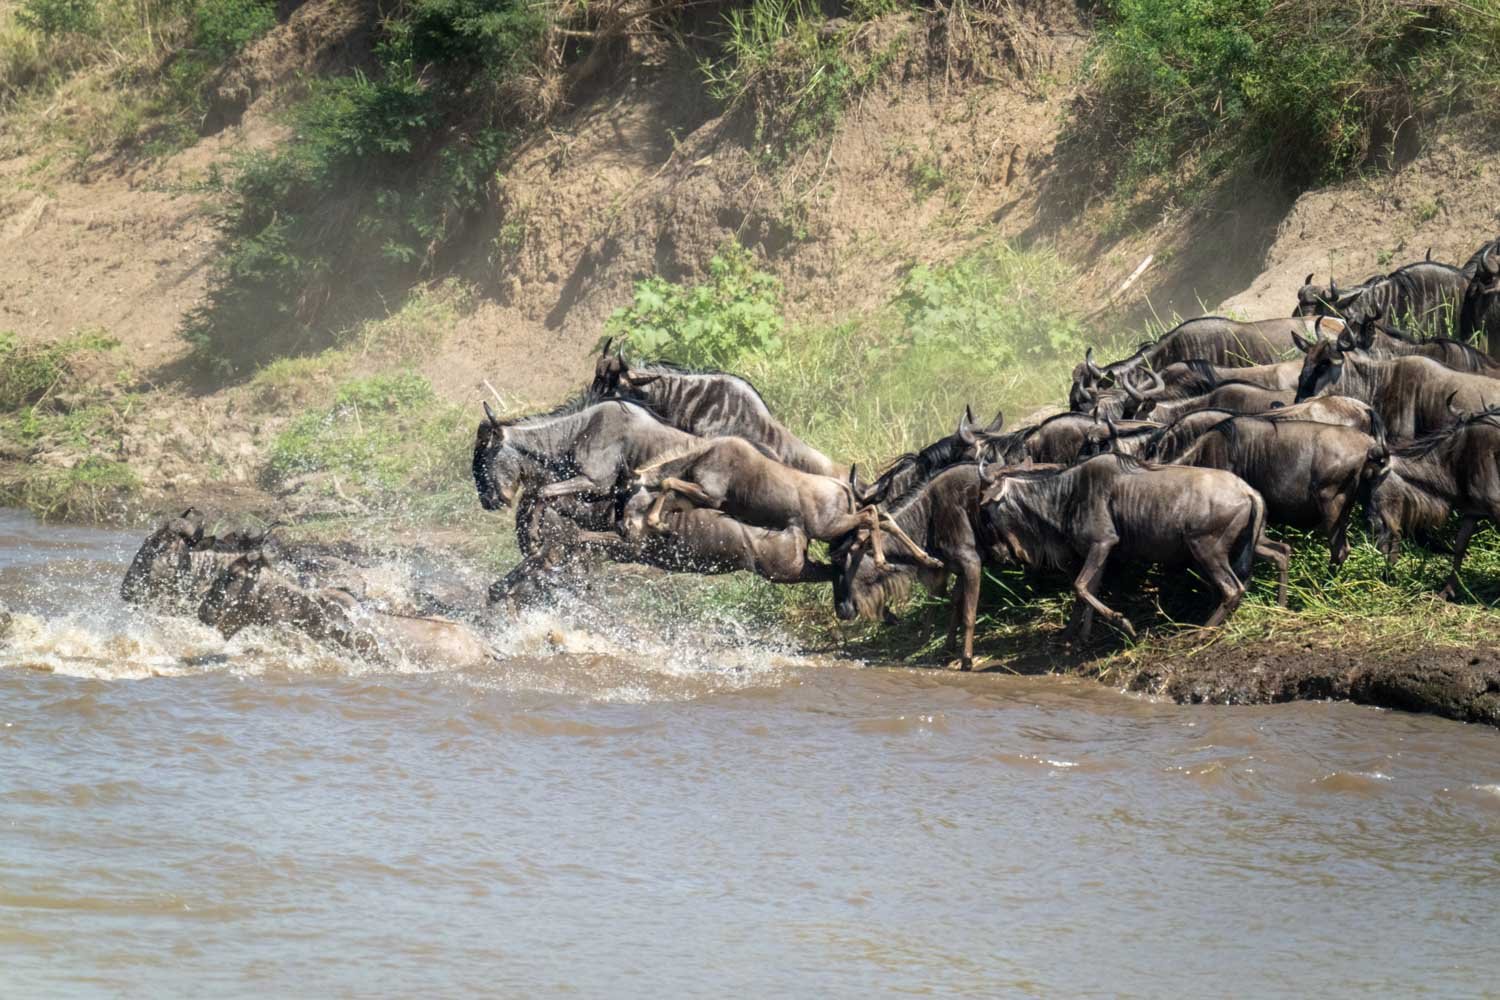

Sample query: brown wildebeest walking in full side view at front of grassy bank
[981,454,1290,642]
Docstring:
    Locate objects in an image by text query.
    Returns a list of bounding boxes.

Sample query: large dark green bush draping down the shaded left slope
[185,0,546,372]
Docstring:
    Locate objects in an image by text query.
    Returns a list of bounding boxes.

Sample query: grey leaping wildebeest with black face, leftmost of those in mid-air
[474,396,702,510]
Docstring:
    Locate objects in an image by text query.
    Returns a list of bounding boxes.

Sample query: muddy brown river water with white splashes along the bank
[0,513,1500,997]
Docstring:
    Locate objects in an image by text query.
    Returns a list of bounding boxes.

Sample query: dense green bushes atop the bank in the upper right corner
[1064,0,1500,192]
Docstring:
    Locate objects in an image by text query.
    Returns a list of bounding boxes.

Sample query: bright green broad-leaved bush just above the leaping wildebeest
[608,243,783,367]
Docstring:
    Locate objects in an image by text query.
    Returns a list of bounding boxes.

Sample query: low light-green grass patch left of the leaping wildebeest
[266,372,473,505]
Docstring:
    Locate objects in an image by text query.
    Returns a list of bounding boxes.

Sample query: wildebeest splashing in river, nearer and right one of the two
[198,550,498,667]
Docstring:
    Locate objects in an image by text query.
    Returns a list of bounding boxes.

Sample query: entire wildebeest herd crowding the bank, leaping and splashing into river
[123,240,1500,669]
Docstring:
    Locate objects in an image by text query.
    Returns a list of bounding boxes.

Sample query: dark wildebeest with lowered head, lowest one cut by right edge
[1365,409,1500,598]
